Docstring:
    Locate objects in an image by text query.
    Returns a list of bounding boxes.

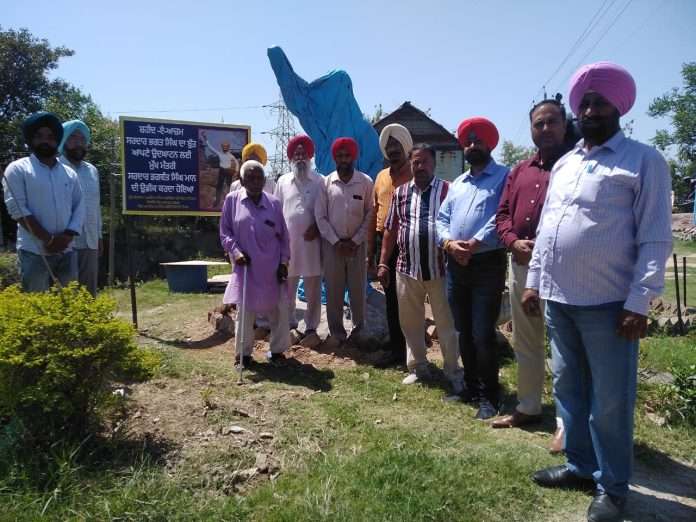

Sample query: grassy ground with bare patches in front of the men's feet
[0,281,696,521]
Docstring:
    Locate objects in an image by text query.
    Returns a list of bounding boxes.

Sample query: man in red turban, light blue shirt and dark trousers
[437,117,508,420]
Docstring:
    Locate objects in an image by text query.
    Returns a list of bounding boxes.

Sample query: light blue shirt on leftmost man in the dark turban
[2,154,85,254]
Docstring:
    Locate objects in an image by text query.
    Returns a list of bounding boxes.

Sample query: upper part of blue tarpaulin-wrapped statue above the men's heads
[268,47,384,179]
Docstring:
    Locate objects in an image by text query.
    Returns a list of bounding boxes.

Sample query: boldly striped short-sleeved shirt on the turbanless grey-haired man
[384,177,449,281]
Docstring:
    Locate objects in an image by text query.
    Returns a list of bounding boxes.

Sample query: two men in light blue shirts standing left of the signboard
[2,112,102,296]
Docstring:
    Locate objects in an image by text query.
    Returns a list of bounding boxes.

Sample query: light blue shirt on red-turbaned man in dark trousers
[437,159,510,253]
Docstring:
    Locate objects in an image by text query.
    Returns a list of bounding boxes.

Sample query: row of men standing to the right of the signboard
[220,62,672,521]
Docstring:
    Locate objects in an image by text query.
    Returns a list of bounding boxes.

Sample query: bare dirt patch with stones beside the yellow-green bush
[120,378,296,494]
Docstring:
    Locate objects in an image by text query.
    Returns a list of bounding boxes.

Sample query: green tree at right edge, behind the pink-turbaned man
[648,62,696,207]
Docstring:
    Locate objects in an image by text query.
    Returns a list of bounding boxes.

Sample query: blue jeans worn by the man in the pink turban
[545,301,638,497]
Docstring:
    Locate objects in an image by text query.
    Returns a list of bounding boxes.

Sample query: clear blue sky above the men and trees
[5,0,696,161]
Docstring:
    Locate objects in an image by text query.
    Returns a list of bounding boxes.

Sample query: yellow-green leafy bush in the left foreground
[0,284,156,444]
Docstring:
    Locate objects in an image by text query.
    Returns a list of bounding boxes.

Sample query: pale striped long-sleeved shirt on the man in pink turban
[527,131,672,315]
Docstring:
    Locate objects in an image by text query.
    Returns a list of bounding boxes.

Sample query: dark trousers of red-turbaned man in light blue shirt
[447,250,507,407]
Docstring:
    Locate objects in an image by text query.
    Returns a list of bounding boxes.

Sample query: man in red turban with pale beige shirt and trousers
[314,138,373,348]
